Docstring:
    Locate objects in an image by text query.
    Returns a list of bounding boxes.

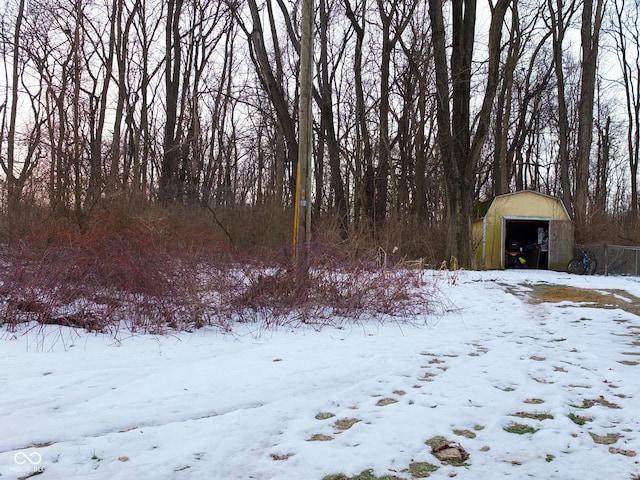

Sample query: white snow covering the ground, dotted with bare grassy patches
[0,270,640,480]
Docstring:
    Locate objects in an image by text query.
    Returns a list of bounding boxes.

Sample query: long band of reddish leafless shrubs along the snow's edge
[0,212,439,337]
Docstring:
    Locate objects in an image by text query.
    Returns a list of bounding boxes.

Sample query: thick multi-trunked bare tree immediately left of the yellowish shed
[429,0,510,267]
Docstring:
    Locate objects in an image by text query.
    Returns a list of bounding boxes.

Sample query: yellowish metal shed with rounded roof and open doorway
[473,190,574,271]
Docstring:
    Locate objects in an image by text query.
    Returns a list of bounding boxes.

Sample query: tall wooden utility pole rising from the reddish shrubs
[293,0,313,270]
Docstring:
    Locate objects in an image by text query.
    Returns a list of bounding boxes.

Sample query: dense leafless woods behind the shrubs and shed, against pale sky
[0,0,640,266]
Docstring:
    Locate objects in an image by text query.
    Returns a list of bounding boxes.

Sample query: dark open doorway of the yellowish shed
[503,218,549,270]
